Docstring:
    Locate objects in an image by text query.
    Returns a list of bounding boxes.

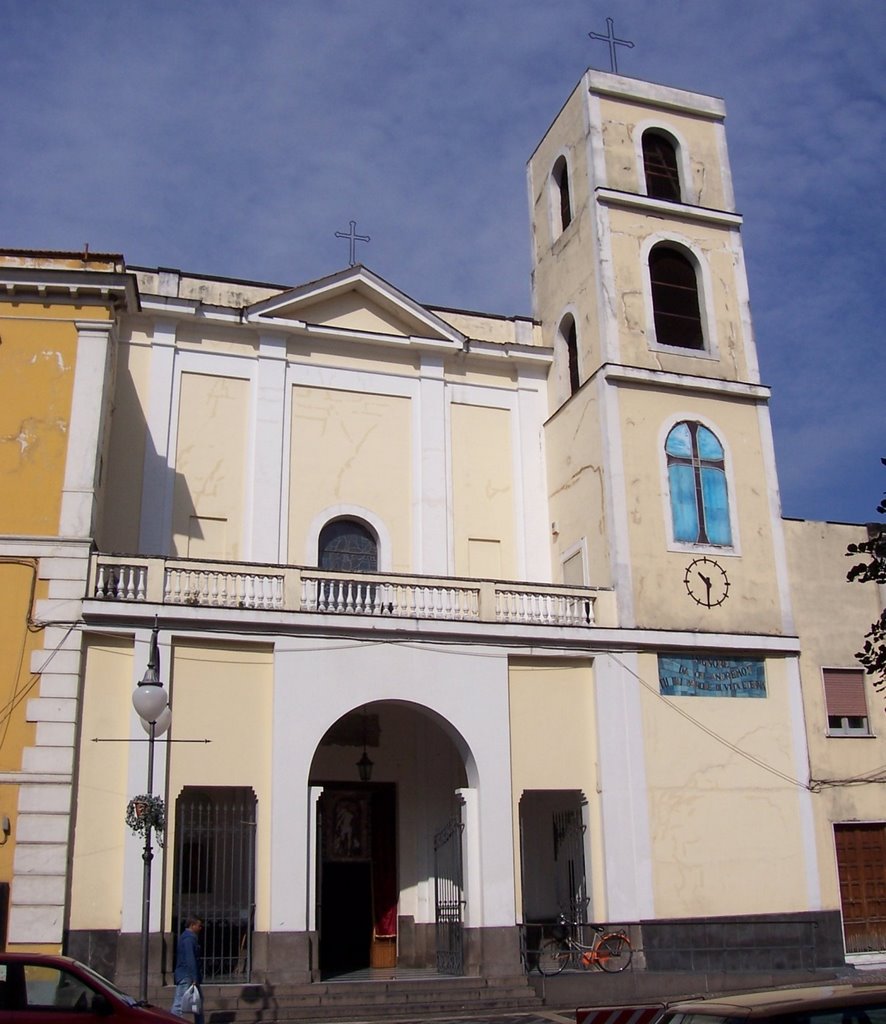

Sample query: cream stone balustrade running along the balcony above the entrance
[89,554,609,627]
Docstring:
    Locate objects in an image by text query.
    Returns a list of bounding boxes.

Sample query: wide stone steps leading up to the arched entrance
[149,971,543,1024]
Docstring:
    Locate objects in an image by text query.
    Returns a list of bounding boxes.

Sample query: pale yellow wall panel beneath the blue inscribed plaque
[639,654,808,918]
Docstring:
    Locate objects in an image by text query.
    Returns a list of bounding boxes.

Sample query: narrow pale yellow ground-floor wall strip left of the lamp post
[71,636,133,930]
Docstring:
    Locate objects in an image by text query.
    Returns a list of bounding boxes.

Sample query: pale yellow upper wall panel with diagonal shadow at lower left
[172,374,249,560]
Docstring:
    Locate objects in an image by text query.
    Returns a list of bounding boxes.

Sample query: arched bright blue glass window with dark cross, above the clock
[665,421,732,547]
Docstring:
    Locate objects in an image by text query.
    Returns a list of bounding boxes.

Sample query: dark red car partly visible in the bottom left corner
[0,952,182,1024]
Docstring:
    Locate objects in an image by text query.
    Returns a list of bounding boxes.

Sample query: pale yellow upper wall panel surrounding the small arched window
[289,387,413,572]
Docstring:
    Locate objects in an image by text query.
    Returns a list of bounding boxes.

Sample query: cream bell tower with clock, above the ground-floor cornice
[529,71,792,633]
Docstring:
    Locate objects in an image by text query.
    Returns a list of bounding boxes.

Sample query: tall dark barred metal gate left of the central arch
[172,786,257,982]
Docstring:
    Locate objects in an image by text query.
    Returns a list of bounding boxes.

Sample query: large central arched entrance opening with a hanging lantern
[310,701,468,976]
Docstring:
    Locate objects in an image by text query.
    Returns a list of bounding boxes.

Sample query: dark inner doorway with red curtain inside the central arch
[318,783,399,976]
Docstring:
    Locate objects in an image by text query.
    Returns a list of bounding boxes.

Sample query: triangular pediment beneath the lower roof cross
[241,266,464,344]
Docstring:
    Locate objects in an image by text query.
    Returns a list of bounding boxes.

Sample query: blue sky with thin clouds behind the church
[0,0,886,522]
